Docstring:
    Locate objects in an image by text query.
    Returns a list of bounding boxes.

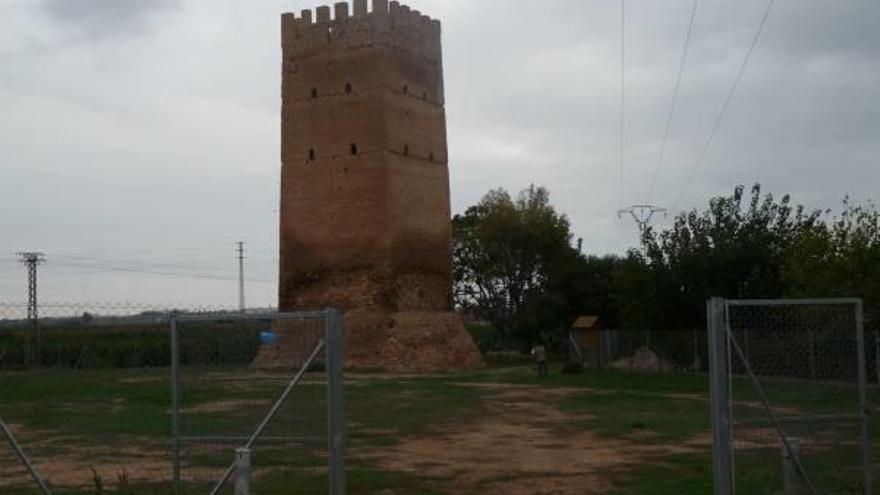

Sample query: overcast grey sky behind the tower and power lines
[0,0,880,305]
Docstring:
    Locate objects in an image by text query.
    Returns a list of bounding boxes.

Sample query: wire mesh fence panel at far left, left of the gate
[0,304,180,494]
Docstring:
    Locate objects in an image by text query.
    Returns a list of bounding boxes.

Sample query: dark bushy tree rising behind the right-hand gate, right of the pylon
[635,184,821,328]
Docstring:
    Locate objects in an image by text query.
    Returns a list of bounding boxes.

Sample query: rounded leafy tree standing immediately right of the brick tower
[453,185,580,345]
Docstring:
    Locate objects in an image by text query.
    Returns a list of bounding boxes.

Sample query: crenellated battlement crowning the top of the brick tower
[281,0,441,62]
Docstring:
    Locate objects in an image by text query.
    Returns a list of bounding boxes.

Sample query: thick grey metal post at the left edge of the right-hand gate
[706,297,733,495]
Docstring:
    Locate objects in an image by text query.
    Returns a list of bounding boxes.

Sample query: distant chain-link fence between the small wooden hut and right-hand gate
[568,329,708,372]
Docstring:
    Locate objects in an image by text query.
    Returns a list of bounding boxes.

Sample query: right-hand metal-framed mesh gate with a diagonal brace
[707,298,874,495]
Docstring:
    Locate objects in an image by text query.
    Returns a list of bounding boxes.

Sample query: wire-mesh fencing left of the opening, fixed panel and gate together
[0,303,342,495]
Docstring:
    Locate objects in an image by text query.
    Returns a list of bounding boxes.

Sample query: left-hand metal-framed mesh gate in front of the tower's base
[170,310,345,495]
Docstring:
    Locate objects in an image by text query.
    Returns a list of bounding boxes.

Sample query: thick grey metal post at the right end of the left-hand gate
[326,309,345,495]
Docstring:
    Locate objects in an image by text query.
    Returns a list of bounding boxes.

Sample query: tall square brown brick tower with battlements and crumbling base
[279,0,480,369]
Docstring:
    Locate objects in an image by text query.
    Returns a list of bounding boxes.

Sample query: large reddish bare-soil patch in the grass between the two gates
[356,385,703,495]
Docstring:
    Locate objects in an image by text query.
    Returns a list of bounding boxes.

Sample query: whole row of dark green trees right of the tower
[453,185,880,347]
